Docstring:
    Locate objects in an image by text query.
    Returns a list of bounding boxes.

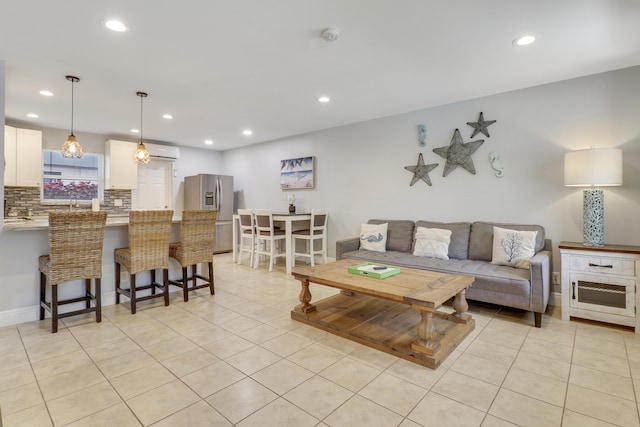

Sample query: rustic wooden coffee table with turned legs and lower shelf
[291,259,475,368]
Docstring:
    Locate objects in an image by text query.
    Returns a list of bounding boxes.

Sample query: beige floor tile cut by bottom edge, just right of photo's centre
[325,395,403,427]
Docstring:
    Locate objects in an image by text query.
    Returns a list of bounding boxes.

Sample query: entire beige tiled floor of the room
[0,255,640,427]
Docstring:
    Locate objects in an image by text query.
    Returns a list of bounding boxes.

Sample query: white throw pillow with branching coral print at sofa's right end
[491,227,538,269]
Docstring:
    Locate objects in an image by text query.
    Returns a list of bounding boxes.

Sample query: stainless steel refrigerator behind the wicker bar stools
[184,174,233,253]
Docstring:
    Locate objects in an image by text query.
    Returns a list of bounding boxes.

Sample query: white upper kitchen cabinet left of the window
[4,125,42,187]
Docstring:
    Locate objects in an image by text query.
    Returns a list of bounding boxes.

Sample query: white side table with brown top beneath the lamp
[559,242,640,333]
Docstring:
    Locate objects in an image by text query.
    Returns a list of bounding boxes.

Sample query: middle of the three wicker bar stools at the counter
[113,210,173,314]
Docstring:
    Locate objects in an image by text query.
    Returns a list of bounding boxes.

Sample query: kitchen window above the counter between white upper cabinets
[40,150,103,202]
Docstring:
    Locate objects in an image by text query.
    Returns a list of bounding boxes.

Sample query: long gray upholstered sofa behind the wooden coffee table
[336,219,552,328]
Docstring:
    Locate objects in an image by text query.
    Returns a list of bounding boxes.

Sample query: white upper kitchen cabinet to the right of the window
[104,139,138,190]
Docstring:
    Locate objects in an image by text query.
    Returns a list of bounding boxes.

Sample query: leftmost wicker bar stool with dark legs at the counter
[38,211,107,333]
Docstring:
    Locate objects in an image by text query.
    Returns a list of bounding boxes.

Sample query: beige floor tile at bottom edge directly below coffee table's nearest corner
[407,392,485,427]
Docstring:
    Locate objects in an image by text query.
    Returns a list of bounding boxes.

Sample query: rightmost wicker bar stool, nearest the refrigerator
[169,210,218,302]
